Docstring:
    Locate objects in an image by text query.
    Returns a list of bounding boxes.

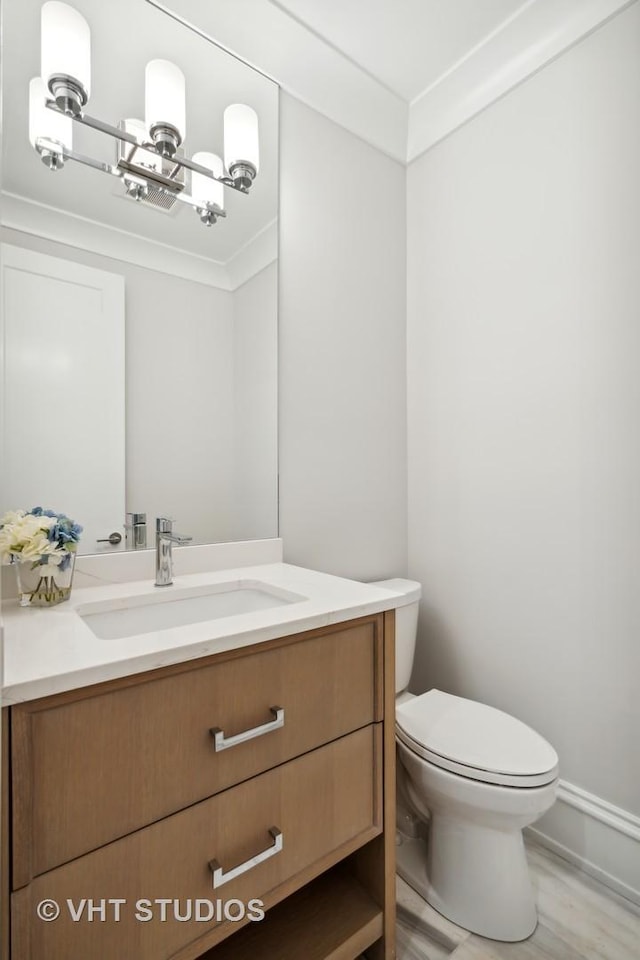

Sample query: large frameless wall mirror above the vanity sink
[0,0,278,553]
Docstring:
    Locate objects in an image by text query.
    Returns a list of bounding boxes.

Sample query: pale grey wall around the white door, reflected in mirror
[0,228,236,540]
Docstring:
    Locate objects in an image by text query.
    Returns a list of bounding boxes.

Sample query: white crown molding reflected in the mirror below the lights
[0,190,278,292]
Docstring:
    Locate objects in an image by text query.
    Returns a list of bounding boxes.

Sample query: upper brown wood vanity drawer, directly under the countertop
[11,617,382,889]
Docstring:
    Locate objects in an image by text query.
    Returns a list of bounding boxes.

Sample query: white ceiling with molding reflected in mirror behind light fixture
[2,0,278,277]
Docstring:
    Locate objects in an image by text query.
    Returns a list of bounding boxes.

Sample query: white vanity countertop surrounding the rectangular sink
[1,563,408,705]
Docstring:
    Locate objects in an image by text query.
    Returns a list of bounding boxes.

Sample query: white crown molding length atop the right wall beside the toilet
[407,0,636,163]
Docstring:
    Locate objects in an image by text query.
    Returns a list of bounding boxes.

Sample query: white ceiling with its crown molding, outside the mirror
[161,0,640,163]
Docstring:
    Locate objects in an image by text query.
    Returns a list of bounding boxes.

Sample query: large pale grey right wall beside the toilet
[407,4,640,892]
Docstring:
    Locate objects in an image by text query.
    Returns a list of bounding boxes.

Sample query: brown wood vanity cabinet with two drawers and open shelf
[2,612,395,960]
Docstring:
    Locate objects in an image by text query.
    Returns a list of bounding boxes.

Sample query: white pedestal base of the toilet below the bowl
[396,816,538,942]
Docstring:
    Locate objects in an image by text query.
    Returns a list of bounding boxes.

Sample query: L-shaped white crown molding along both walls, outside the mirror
[154,0,636,164]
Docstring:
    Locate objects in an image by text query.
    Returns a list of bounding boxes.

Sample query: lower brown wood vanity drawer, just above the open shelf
[12,724,382,960]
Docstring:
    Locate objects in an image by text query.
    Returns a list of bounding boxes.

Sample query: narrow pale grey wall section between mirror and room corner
[279,94,406,579]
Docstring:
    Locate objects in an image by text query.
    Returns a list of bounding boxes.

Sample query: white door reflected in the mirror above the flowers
[0,244,125,553]
